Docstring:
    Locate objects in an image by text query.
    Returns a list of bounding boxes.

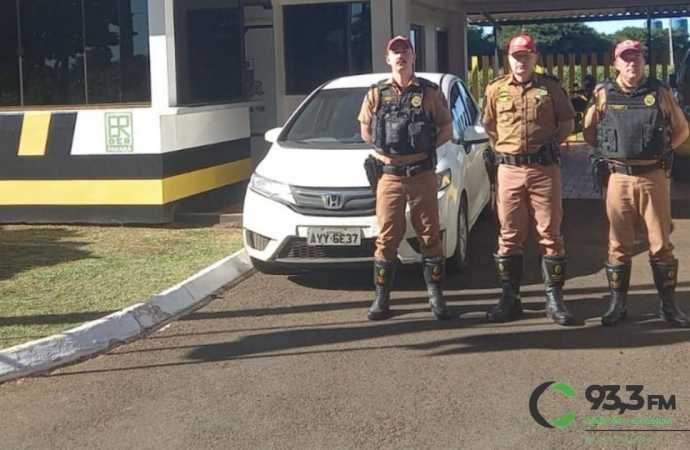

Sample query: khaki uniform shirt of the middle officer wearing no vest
[482,73,575,155]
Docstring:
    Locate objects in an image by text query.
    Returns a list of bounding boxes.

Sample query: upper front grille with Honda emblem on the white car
[290,186,376,217]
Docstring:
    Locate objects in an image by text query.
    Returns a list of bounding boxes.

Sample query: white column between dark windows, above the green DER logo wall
[148,0,177,109]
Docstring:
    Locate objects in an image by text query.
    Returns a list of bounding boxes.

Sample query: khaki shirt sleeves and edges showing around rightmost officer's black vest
[582,77,688,165]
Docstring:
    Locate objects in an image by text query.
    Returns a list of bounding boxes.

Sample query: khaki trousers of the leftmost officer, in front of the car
[374,170,443,262]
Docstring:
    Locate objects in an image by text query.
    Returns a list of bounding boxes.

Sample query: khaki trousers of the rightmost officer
[606,169,674,264]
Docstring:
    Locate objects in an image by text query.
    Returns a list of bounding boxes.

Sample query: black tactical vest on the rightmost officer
[597,78,671,159]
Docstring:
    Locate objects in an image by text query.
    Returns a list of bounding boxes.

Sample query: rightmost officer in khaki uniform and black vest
[583,40,690,327]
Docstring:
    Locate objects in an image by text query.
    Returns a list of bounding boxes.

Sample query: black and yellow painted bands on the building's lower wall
[0,112,252,223]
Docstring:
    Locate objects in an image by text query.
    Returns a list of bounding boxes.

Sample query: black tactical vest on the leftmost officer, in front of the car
[371,78,438,155]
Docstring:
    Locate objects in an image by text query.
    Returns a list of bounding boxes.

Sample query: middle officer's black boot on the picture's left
[486,255,523,322]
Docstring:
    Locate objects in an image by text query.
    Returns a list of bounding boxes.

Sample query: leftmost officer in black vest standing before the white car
[359,36,452,320]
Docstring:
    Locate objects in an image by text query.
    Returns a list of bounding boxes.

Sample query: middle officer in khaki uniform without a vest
[483,34,575,325]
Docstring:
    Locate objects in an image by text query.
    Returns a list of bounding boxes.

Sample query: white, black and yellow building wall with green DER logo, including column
[0,0,252,223]
